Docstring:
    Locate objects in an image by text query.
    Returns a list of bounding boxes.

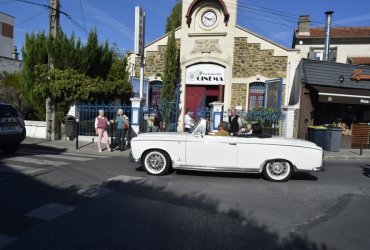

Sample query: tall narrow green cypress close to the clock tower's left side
[161,30,179,126]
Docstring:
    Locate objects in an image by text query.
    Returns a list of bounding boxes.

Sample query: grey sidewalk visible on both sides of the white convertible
[22,138,370,160]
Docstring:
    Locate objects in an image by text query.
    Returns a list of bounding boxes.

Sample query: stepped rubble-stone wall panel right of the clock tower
[232,37,287,78]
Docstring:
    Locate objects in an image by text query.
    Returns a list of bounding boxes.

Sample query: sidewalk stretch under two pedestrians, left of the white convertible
[21,137,131,157]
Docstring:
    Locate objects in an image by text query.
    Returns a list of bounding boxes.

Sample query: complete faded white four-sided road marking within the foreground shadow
[25,203,74,221]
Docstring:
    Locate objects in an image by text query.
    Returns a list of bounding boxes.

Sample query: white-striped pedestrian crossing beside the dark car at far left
[0,151,108,175]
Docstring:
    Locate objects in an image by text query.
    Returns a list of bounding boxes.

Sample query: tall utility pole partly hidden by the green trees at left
[46,0,60,141]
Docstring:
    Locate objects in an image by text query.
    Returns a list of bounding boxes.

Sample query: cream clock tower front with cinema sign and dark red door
[178,0,237,119]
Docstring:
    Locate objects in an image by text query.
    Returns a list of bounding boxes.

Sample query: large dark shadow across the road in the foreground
[0,161,328,250]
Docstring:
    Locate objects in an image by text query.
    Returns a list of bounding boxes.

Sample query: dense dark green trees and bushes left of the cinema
[20,30,130,121]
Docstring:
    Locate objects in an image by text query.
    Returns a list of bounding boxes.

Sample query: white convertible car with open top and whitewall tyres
[130,119,324,181]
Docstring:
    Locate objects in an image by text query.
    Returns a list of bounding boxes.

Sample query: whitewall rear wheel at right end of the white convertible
[263,160,293,182]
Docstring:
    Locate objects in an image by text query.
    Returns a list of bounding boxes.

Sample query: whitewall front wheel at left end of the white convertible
[143,150,171,175]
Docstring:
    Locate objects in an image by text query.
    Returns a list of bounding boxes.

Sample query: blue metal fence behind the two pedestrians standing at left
[77,103,131,136]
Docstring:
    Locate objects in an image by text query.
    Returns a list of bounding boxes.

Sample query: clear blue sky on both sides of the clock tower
[0,0,370,56]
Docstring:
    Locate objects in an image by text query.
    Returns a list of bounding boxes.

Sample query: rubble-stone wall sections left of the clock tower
[135,39,181,77]
